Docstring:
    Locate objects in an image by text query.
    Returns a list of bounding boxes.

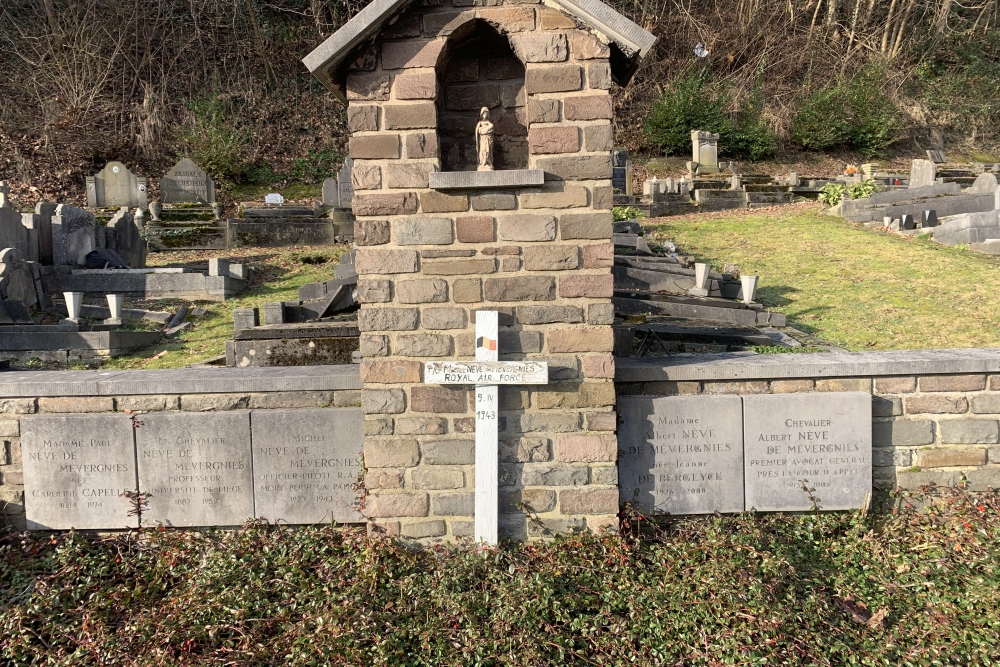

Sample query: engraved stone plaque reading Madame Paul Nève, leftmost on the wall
[21,414,137,530]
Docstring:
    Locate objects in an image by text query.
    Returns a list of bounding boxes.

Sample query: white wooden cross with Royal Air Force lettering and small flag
[424,310,549,544]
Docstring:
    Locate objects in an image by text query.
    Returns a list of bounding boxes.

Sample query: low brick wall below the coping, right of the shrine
[616,373,1000,491]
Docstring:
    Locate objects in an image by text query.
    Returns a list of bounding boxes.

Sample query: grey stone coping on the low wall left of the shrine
[0,364,361,398]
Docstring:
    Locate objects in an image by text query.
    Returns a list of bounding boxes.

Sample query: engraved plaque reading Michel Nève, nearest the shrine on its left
[250,408,364,524]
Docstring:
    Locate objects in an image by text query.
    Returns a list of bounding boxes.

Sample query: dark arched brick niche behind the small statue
[437,20,528,171]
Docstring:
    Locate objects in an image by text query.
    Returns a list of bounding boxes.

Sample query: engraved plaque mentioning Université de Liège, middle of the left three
[135,410,253,526]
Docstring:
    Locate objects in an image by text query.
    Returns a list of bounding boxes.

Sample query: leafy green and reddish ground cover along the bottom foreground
[0,492,1000,667]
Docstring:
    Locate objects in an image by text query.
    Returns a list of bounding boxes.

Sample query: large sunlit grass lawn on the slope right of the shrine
[644,204,1000,350]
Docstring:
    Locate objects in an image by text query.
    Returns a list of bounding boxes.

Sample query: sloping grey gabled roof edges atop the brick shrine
[302,0,656,103]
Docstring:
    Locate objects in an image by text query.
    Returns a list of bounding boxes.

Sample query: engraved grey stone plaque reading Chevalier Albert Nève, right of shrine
[743,392,872,511]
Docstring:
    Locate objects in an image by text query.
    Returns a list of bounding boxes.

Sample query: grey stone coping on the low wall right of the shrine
[615,348,1000,382]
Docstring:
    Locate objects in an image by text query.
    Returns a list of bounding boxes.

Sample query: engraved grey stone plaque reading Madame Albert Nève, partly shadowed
[618,396,743,514]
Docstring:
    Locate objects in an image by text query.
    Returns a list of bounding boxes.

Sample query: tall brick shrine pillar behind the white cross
[347,0,618,539]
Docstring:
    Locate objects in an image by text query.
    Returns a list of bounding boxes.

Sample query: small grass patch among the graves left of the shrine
[101,245,349,369]
